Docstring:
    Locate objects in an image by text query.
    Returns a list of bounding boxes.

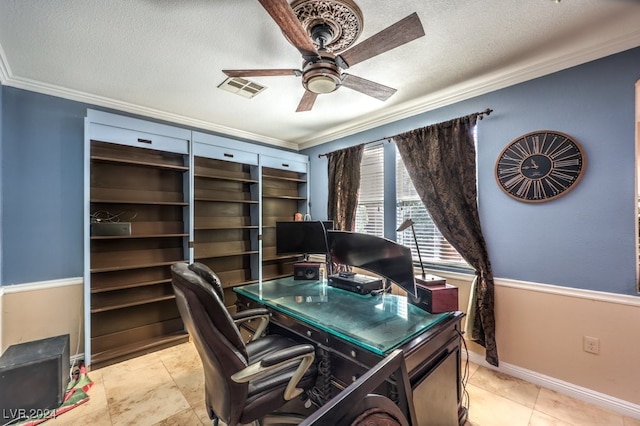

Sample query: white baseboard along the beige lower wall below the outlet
[469,351,640,419]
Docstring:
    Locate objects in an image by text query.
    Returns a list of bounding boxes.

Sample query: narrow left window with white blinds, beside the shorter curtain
[356,145,384,237]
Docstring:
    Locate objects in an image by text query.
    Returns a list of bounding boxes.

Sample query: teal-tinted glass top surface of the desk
[234,277,453,356]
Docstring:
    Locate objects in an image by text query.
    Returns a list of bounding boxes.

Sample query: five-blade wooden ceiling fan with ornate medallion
[228,0,425,112]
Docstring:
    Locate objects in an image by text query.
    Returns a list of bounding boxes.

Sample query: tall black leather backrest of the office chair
[171,263,248,424]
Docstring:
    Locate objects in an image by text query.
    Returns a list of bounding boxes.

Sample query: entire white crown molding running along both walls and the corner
[0,26,640,151]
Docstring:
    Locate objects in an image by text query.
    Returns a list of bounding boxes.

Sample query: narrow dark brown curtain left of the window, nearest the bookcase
[327,144,364,231]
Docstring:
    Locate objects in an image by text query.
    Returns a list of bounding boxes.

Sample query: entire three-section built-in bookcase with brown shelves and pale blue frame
[84,110,308,368]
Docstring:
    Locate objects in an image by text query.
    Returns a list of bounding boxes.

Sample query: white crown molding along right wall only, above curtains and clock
[298,31,640,149]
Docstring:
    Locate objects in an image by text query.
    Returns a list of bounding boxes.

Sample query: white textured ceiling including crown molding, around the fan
[0,0,640,148]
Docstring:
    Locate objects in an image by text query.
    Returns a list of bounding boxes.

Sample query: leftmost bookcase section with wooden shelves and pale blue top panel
[85,113,190,368]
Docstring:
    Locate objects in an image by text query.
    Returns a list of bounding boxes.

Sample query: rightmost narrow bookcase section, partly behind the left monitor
[261,157,308,280]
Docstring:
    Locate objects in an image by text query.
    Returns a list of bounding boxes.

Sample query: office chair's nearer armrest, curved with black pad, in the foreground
[231,344,316,401]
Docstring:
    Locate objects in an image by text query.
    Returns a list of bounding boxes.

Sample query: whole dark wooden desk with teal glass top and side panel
[234,277,466,425]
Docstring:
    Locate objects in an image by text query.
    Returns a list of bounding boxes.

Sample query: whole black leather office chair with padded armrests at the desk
[171,263,317,426]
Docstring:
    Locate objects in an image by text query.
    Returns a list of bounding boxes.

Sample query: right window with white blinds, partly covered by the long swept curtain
[396,146,468,267]
